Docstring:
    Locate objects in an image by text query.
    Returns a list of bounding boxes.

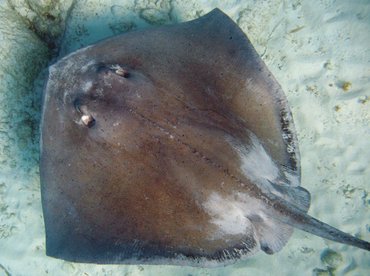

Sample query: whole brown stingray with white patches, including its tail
[40,9,370,266]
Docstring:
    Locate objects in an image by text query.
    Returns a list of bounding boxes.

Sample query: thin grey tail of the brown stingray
[268,195,370,251]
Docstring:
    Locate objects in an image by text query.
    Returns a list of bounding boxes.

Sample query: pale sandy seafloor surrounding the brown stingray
[0,0,370,276]
